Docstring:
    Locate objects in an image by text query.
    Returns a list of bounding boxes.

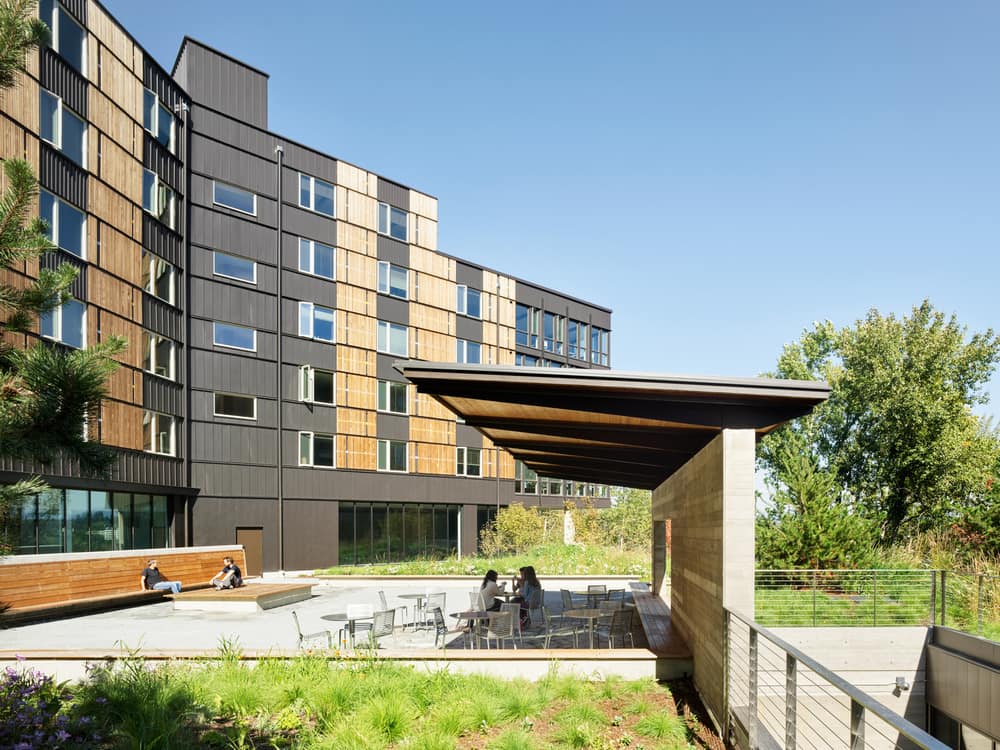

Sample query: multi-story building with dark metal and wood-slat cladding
[0,0,611,569]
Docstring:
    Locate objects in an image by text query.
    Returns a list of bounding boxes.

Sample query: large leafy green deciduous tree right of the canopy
[758,300,1000,544]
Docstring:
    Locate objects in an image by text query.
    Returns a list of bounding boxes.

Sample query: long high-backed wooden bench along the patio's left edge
[0,545,246,626]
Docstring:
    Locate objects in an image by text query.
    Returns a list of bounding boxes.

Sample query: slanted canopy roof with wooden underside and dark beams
[395,361,830,489]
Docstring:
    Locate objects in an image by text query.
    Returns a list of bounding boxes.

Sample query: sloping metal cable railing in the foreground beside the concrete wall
[725,609,948,750]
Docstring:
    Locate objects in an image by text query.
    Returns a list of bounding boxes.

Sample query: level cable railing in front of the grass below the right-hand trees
[755,569,1000,640]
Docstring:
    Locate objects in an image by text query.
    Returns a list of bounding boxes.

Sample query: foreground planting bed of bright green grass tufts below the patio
[11,649,723,750]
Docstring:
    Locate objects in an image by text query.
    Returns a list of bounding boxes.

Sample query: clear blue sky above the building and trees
[105,0,1000,417]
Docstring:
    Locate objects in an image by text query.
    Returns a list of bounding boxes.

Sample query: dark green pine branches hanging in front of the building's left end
[0,0,125,552]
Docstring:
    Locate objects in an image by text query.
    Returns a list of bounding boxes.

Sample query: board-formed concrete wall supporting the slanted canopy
[653,430,755,722]
